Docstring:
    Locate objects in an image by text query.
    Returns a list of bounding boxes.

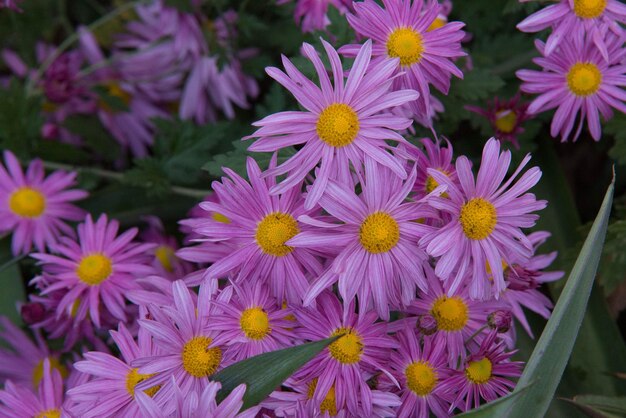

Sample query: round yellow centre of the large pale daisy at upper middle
[316,103,359,147]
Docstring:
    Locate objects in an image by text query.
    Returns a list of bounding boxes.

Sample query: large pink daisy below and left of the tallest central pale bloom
[189,158,324,305]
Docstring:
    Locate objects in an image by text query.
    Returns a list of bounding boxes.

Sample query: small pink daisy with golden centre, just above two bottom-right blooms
[407,269,506,366]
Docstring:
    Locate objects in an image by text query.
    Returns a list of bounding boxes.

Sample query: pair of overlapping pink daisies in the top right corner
[517,0,626,142]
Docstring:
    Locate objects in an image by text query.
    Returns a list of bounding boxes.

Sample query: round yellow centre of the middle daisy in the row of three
[359,212,400,254]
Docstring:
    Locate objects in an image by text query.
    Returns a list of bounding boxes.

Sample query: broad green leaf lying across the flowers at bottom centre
[211,337,338,410]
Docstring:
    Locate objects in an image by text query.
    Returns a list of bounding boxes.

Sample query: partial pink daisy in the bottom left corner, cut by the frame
[0,359,67,418]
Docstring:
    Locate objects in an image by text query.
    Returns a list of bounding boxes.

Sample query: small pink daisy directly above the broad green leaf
[207,282,294,363]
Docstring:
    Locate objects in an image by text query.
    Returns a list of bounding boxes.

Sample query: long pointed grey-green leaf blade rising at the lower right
[462,179,615,418]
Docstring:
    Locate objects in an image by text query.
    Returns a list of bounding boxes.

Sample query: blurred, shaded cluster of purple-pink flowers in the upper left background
[2,0,258,157]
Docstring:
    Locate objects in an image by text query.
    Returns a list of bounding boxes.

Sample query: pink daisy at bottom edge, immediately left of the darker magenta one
[385,327,452,418]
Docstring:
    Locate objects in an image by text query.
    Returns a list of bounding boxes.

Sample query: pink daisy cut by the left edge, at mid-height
[0,151,87,255]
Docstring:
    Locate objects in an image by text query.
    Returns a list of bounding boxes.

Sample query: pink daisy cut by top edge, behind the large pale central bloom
[339,0,466,126]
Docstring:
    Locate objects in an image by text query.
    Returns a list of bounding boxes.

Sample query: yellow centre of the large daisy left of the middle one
[255,212,300,257]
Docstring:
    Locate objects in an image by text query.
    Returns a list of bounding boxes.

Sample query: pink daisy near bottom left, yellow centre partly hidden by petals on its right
[67,323,159,418]
